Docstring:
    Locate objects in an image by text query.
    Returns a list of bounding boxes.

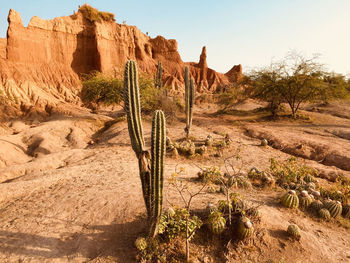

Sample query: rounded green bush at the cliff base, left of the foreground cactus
[80,72,123,107]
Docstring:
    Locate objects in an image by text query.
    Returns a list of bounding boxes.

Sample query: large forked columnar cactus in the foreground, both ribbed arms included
[124,60,166,236]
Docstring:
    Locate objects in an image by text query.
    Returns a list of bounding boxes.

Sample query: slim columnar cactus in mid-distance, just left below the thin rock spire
[185,67,194,137]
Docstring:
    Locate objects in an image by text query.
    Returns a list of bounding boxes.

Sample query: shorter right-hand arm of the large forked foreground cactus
[150,110,166,236]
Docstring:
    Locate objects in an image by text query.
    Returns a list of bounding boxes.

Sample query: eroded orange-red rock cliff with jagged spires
[0,6,241,114]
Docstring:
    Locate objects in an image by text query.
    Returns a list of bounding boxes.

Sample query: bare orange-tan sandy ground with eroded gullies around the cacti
[0,103,350,263]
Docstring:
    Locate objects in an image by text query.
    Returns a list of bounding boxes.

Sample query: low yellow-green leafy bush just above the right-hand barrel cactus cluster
[270,157,317,186]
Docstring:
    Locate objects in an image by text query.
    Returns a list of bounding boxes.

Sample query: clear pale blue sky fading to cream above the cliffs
[0,0,350,74]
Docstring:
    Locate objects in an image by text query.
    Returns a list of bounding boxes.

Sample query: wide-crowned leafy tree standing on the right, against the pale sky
[249,51,346,118]
